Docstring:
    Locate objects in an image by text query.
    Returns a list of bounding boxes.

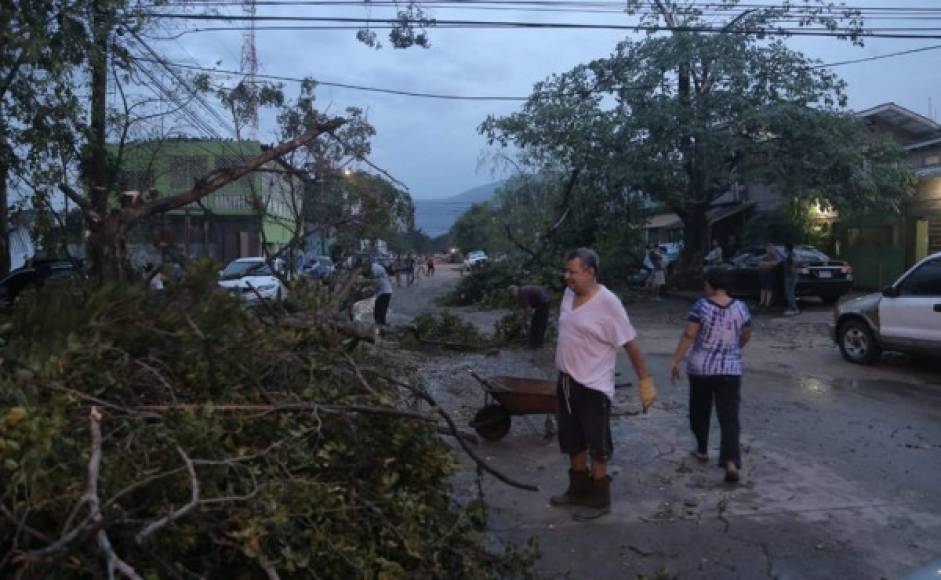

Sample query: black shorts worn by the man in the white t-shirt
[556,373,614,461]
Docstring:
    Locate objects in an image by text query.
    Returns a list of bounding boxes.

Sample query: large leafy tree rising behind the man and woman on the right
[483,1,912,280]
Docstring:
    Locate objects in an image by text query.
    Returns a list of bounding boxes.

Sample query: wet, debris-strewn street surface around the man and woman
[370,266,941,578]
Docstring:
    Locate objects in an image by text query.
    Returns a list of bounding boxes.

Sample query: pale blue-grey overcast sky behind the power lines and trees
[154,0,941,198]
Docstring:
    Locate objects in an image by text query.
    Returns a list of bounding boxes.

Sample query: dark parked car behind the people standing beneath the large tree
[707,246,853,304]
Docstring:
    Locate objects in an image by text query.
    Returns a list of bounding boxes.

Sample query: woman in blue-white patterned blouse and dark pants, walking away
[670,271,751,483]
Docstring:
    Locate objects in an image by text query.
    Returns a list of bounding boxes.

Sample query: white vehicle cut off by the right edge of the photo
[833,252,941,364]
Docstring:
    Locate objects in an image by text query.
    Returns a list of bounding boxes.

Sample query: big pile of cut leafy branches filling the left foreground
[0,271,535,579]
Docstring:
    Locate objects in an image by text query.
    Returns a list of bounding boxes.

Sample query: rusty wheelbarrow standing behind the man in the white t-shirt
[470,371,556,441]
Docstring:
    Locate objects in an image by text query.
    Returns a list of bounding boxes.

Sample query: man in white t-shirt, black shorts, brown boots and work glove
[550,248,656,520]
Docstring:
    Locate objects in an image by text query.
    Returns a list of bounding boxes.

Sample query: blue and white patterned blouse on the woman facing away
[686,298,751,375]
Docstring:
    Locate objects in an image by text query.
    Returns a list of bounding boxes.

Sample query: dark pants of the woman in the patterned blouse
[689,375,742,468]
